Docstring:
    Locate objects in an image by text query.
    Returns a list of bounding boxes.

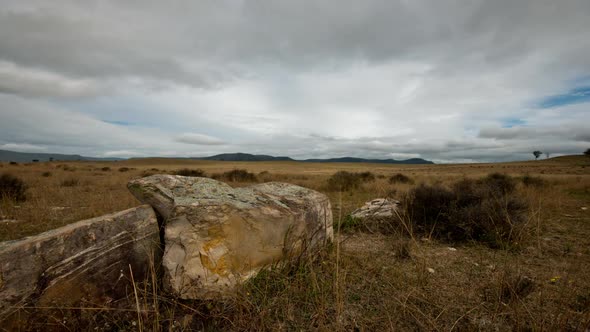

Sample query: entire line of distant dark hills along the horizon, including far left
[0,150,434,164]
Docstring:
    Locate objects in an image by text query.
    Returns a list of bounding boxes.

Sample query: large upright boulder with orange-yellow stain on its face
[128,175,333,299]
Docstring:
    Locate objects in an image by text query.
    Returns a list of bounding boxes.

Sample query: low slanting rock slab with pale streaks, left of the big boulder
[0,205,161,322]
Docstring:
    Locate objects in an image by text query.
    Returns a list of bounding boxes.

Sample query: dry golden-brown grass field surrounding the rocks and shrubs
[0,156,590,331]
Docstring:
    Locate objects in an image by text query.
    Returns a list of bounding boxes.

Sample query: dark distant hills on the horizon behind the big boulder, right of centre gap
[195,153,434,164]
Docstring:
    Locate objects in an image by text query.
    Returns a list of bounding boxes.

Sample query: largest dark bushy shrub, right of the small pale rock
[404,173,528,248]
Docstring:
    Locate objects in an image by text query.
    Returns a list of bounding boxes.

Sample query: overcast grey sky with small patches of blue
[0,0,590,163]
